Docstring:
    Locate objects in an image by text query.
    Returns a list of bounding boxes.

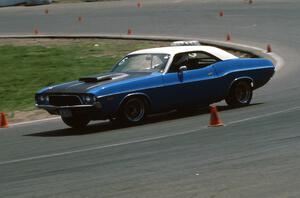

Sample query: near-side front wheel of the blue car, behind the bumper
[119,97,147,124]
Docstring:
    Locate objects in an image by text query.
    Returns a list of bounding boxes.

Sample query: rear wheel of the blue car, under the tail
[225,81,253,107]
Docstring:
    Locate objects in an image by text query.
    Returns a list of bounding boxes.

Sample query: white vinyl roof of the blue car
[129,45,238,60]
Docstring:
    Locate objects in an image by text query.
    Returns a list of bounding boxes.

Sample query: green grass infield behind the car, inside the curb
[0,40,166,112]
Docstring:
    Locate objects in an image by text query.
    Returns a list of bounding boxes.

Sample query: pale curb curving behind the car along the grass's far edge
[0,34,284,71]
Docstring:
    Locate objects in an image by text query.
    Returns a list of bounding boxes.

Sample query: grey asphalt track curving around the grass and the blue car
[0,0,300,198]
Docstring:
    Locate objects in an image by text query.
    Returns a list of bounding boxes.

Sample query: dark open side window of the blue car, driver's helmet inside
[169,52,219,73]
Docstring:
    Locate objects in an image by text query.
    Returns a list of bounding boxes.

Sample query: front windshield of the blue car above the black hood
[112,54,170,72]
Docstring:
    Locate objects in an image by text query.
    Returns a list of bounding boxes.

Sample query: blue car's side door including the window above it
[164,51,219,106]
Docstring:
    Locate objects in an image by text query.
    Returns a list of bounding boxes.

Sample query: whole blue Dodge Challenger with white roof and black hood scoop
[35,42,275,128]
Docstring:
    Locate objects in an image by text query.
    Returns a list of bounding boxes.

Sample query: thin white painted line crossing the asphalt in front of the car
[0,106,300,166]
